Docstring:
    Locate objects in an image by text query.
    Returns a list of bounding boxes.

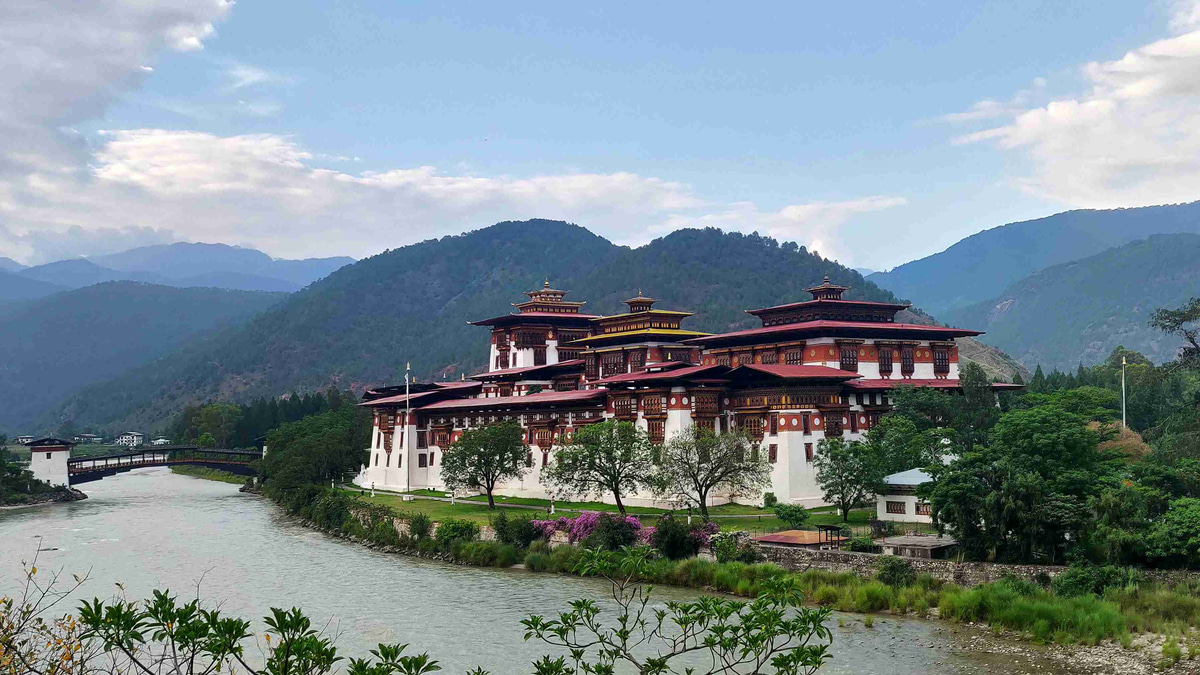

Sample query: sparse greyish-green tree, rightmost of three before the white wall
[653,425,770,518]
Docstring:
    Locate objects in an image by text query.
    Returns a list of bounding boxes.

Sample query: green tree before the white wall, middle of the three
[541,420,654,514]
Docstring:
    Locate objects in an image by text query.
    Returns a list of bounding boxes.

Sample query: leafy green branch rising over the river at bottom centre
[521,546,833,675]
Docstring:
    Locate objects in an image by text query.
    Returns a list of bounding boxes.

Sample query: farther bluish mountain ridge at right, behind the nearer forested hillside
[870,202,1200,318]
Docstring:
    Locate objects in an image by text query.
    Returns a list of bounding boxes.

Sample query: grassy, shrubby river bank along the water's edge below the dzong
[267,482,1200,673]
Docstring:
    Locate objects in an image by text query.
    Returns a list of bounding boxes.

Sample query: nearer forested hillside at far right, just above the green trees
[942,234,1200,370]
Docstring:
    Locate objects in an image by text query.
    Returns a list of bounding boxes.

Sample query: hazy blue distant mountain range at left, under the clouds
[0,243,354,304]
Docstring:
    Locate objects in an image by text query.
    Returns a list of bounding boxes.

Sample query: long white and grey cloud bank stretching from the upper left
[0,0,904,263]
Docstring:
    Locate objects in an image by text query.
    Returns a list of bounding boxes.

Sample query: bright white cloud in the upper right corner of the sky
[947,0,1200,208]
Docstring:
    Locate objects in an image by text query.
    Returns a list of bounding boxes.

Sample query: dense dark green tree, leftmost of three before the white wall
[442,420,527,509]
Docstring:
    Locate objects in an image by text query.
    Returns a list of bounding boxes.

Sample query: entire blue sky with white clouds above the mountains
[0,0,1200,269]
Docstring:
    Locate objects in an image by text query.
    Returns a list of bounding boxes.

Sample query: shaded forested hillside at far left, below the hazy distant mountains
[0,281,283,435]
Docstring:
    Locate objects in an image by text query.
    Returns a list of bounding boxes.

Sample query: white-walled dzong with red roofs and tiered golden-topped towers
[355,277,1003,507]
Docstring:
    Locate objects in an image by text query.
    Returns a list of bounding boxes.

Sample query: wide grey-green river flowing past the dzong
[0,468,1080,675]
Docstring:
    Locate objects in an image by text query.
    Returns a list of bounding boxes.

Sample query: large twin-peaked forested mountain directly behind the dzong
[28,220,1014,428]
